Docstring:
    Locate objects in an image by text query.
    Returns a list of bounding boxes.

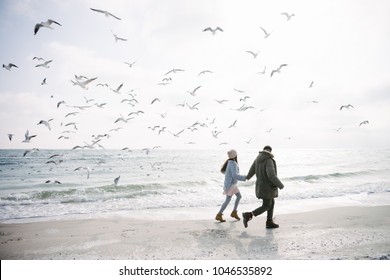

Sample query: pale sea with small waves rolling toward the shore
[0,148,390,223]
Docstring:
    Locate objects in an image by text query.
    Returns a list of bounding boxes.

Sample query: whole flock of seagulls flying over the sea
[3,8,369,186]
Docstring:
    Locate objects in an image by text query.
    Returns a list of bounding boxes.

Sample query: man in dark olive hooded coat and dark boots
[242,146,284,228]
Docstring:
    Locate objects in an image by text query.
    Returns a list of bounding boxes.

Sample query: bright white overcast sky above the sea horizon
[0,0,390,149]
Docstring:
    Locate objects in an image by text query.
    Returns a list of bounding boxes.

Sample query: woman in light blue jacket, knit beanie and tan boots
[215,150,246,222]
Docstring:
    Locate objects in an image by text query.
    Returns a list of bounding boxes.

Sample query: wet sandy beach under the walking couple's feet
[0,203,390,260]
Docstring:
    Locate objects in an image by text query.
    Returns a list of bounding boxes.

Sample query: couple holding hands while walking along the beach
[215,146,284,228]
